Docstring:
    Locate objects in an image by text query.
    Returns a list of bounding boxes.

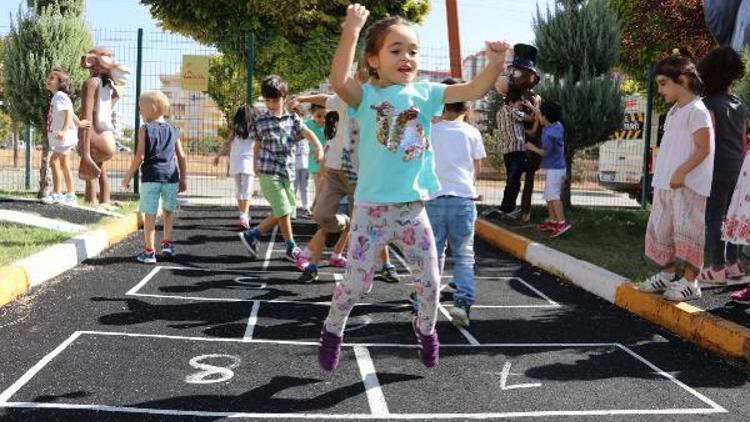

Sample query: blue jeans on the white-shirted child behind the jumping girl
[427,196,477,306]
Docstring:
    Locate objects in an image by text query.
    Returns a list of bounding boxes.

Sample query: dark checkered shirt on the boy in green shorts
[250,111,305,180]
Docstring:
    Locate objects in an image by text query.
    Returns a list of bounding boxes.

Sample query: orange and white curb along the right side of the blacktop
[476,219,750,361]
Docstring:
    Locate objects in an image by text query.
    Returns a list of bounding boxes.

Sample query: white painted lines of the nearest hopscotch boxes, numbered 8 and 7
[0,331,726,420]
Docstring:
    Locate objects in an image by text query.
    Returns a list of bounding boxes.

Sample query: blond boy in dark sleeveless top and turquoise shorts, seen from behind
[122,91,187,264]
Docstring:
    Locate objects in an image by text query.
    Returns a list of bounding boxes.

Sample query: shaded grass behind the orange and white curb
[489,206,656,281]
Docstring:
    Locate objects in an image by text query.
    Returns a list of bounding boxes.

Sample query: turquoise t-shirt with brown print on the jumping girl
[349,82,446,204]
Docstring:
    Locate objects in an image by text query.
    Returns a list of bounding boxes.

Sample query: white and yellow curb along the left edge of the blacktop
[0,213,139,306]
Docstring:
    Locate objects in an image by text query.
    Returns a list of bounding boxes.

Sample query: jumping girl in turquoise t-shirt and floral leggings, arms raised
[318,4,510,371]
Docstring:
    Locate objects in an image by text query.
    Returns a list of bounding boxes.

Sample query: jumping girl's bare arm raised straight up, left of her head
[329,4,370,107]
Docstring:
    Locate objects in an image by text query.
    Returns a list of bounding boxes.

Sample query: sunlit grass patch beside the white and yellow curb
[0,222,71,265]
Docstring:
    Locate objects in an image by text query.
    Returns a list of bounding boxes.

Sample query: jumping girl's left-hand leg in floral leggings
[324,206,397,337]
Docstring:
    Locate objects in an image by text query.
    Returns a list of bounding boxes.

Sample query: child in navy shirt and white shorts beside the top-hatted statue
[524,100,573,238]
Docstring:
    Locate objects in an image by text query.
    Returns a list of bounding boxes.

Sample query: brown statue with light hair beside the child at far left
[78,47,129,206]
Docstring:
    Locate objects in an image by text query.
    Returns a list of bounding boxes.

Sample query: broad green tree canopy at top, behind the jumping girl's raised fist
[141,0,430,92]
